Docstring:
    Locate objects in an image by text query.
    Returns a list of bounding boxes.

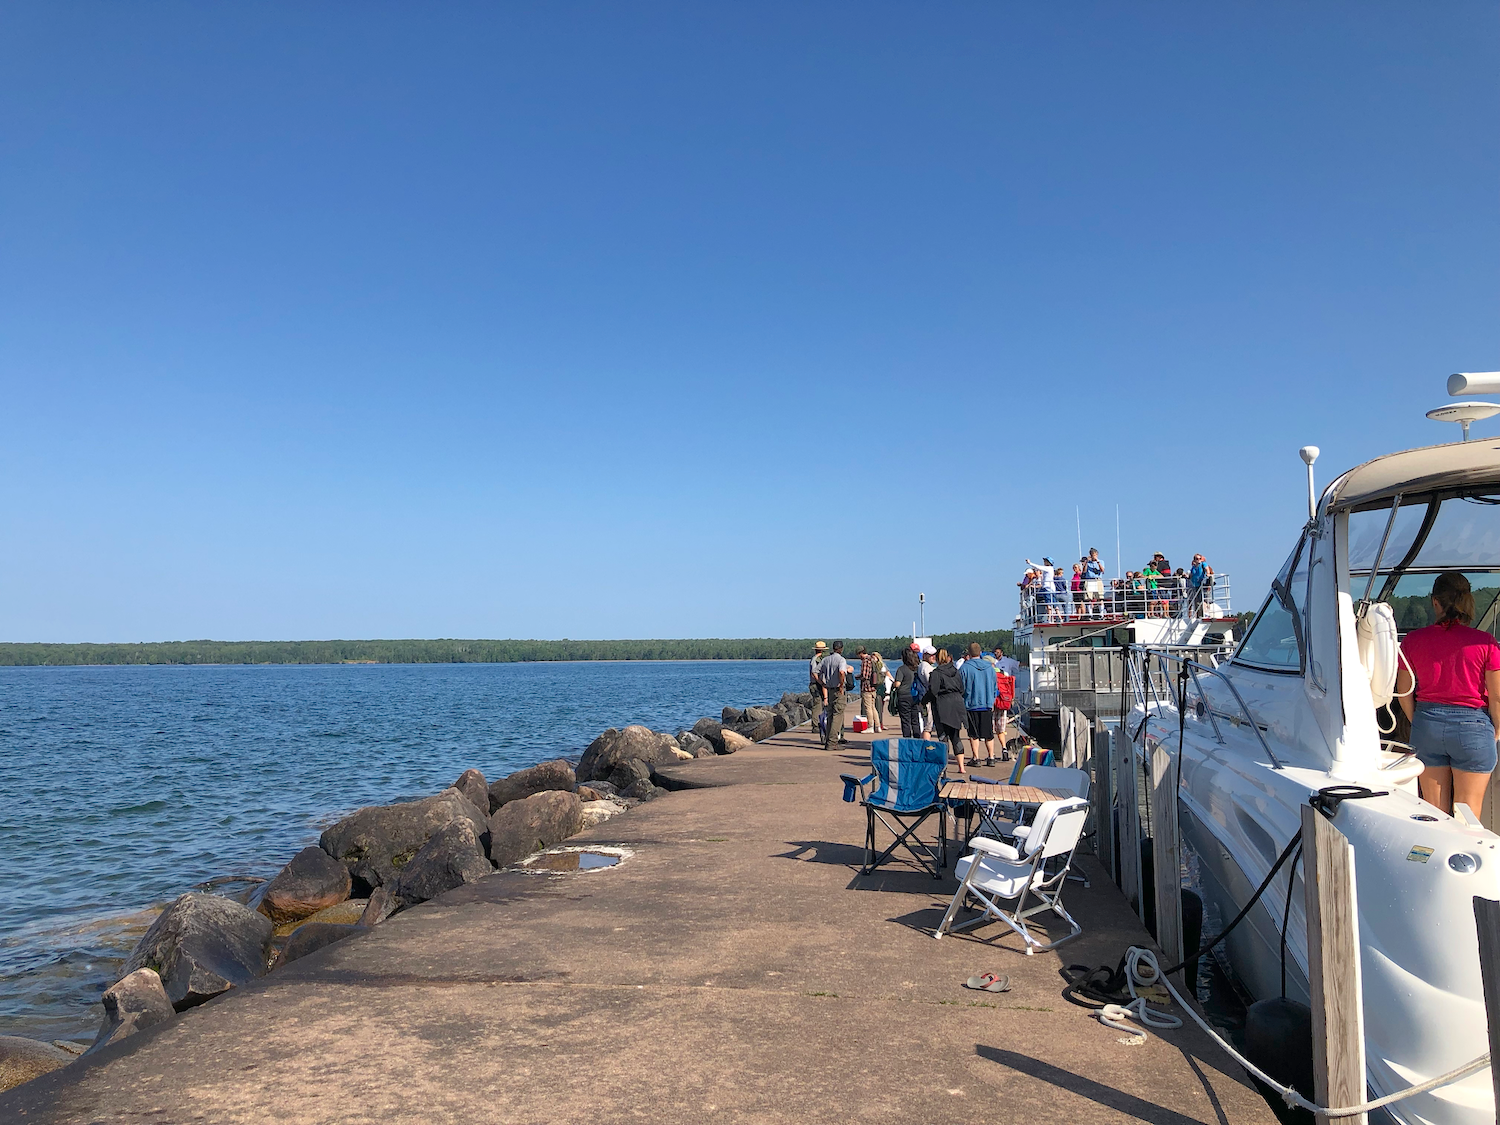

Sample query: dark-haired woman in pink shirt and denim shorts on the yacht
[1397,570,1500,816]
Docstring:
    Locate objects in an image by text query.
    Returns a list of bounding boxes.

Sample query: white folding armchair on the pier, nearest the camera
[933,797,1089,957]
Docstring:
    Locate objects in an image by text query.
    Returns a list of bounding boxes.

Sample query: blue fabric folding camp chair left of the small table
[839,738,948,879]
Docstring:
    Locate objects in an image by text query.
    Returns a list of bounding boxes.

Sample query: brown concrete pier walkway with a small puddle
[0,717,1275,1125]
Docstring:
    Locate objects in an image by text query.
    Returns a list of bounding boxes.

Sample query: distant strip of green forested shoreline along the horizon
[0,629,1011,668]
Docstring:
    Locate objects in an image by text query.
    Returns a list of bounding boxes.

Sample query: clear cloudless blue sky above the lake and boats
[0,0,1500,641]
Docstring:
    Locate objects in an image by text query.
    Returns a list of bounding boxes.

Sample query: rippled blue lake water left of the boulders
[0,660,807,1038]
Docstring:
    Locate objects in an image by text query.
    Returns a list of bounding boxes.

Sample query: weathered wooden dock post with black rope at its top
[1302,804,1367,1125]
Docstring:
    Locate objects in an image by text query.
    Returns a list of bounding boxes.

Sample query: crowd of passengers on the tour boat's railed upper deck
[1016,548,1214,621]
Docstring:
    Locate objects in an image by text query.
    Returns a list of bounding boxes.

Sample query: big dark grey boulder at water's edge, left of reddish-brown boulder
[122,893,272,1011]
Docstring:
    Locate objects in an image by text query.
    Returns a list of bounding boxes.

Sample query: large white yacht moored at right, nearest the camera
[1127,440,1500,1125]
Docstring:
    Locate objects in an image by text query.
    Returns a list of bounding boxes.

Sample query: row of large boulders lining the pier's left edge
[0,692,813,1091]
